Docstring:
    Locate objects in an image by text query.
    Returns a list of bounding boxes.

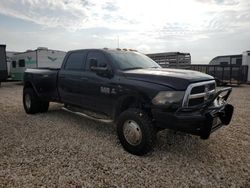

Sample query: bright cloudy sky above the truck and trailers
[0,0,250,63]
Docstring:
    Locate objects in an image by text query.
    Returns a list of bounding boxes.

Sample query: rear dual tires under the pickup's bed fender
[23,88,49,114]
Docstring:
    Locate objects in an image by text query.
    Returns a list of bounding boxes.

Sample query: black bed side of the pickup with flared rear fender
[24,68,60,102]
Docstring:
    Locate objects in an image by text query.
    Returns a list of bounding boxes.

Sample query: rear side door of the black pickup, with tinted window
[58,51,87,106]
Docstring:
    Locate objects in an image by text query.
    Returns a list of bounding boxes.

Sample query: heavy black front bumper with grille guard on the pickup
[152,88,234,139]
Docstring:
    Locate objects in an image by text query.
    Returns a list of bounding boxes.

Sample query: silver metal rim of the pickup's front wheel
[123,120,142,146]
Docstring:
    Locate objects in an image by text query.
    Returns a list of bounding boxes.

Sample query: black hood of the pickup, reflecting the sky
[123,68,214,90]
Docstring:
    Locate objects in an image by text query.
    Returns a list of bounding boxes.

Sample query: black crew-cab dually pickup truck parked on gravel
[23,49,233,155]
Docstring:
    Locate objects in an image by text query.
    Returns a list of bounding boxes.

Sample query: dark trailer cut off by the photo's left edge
[0,45,8,85]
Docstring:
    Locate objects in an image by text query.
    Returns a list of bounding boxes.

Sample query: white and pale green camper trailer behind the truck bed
[10,47,66,81]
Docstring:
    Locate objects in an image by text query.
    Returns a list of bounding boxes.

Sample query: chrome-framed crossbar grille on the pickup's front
[182,80,216,107]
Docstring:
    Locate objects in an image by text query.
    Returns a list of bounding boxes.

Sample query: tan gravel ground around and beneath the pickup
[0,83,250,187]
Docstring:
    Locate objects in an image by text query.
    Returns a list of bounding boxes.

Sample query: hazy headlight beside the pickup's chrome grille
[152,91,185,105]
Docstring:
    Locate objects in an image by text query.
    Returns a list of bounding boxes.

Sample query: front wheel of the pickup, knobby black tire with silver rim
[117,109,156,155]
